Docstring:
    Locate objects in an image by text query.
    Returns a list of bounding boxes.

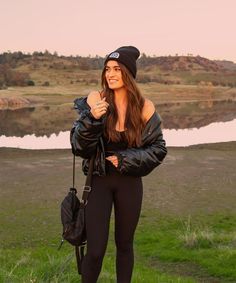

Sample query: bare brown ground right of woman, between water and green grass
[144,142,236,215]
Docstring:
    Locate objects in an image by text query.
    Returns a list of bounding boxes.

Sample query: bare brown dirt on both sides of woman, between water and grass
[0,142,236,215]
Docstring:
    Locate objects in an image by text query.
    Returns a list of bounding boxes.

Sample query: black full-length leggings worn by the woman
[82,173,143,283]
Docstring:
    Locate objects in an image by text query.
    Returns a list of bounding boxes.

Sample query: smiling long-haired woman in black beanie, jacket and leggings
[71,46,167,283]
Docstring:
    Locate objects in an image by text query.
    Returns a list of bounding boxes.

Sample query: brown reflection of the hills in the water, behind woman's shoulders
[0,101,236,136]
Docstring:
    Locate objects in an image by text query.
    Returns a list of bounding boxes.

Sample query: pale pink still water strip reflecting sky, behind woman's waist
[0,119,236,149]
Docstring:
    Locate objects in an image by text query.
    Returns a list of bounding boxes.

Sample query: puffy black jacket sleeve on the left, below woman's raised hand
[70,109,104,158]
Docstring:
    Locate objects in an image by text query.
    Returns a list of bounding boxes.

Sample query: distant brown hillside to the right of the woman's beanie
[138,56,236,87]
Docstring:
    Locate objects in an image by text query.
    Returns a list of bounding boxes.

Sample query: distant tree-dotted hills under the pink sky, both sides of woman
[0,51,236,88]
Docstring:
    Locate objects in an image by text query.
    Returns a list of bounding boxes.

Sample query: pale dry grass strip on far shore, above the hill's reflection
[0,83,236,105]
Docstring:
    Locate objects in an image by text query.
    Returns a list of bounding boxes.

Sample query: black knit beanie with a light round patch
[104,46,140,78]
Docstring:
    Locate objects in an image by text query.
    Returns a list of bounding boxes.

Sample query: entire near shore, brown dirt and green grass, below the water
[0,142,236,283]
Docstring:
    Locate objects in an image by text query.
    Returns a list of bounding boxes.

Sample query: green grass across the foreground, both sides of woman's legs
[0,210,236,283]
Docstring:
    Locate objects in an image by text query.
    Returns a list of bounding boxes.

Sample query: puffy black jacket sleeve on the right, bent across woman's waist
[117,115,167,176]
